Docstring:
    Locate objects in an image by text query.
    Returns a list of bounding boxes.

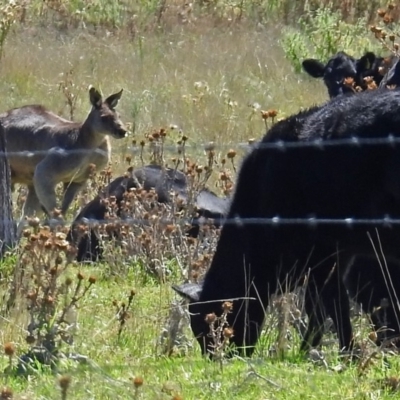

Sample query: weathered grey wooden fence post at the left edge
[0,124,16,258]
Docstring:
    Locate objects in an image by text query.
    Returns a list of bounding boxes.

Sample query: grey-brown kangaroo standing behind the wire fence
[0,86,127,236]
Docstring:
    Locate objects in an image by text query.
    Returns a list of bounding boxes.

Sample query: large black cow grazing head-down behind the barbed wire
[174,90,400,355]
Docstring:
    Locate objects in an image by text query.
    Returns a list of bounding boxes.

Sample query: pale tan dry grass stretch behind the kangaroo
[0,22,326,173]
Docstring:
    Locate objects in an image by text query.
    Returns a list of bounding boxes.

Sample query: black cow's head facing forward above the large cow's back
[302,51,385,98]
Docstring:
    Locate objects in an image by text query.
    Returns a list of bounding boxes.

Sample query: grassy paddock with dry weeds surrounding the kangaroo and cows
[0,0,399,400]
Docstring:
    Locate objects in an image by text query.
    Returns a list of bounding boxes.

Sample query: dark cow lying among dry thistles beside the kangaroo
[67,165,229,262]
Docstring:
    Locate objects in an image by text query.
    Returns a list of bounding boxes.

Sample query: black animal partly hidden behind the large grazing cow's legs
[344,255,400,347]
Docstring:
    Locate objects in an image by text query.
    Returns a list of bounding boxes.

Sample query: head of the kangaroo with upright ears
[88,86,128,139]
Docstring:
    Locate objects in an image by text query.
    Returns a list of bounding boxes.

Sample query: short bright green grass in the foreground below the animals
[0,258,400,400]
